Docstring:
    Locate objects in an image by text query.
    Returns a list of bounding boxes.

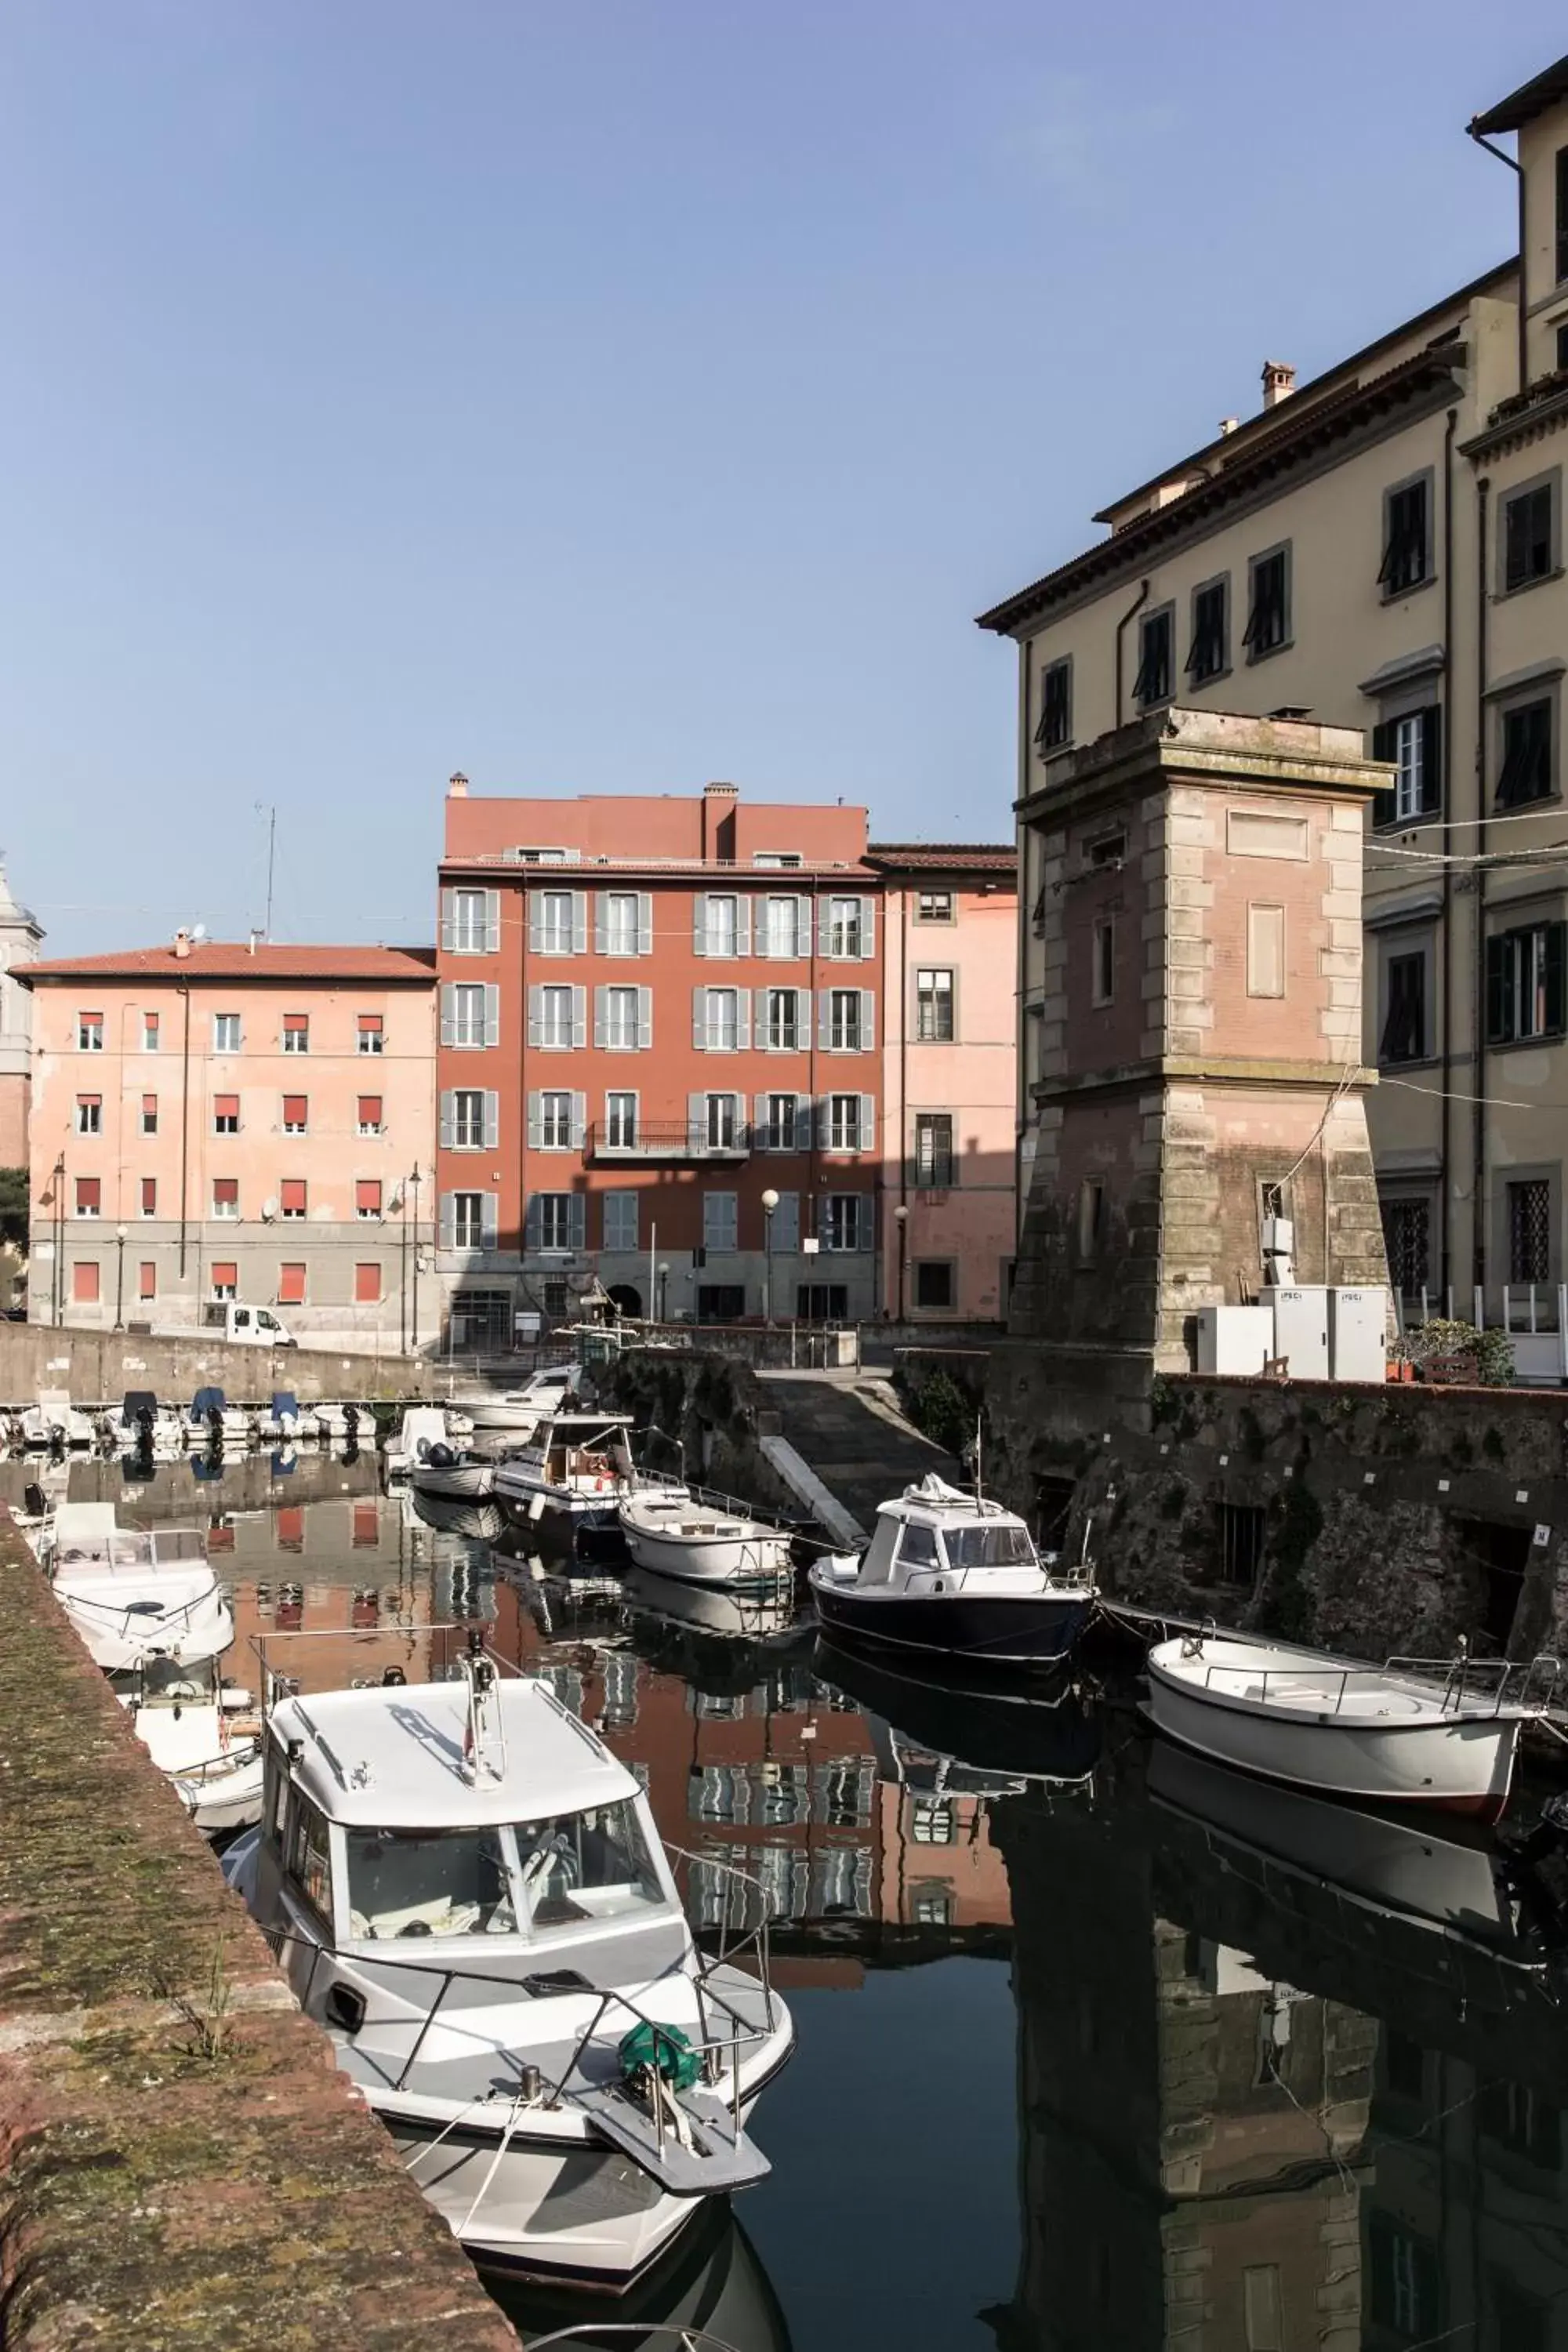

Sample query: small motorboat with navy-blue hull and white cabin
[811,1472,1095,1665]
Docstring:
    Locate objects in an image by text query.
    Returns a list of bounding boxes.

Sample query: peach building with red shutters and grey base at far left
[23,934,440,1348]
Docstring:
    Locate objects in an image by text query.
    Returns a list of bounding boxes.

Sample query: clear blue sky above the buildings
[0,0,1563,948]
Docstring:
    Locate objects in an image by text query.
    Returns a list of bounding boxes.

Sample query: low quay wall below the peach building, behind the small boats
[0,1324,434,1404]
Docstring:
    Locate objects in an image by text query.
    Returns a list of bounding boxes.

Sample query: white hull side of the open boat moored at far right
[1149,1663,1519,1820]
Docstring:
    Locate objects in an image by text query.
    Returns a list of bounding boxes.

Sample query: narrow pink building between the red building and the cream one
[867,842,1018,1324]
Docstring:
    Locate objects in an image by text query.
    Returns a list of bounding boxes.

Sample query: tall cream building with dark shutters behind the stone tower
[980,59,1568,1322]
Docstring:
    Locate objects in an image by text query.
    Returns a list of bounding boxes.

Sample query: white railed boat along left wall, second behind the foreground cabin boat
[40,1503,235,1675]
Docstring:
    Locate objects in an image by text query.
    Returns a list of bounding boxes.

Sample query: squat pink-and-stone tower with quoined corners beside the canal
[1011,708,1389,1397]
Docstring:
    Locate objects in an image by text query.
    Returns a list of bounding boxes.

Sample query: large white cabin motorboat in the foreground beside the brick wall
[226,1649,794,2288]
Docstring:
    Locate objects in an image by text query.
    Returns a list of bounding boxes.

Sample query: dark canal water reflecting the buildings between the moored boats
[18,1454,1568,2352]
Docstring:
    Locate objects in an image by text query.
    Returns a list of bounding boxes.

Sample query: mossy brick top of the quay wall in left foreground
[0,1515,517,2352]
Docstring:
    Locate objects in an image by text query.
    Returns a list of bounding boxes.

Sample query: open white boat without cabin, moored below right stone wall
[1149,1628,1559,1820]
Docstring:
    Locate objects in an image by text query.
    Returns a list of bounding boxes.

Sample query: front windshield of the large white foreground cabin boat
[343,1799,666,1943]
